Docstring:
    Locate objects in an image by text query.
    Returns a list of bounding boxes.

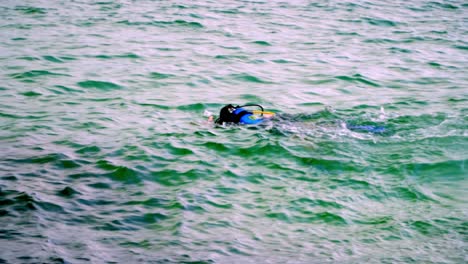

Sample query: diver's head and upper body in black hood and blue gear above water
[208,104,275,125]
